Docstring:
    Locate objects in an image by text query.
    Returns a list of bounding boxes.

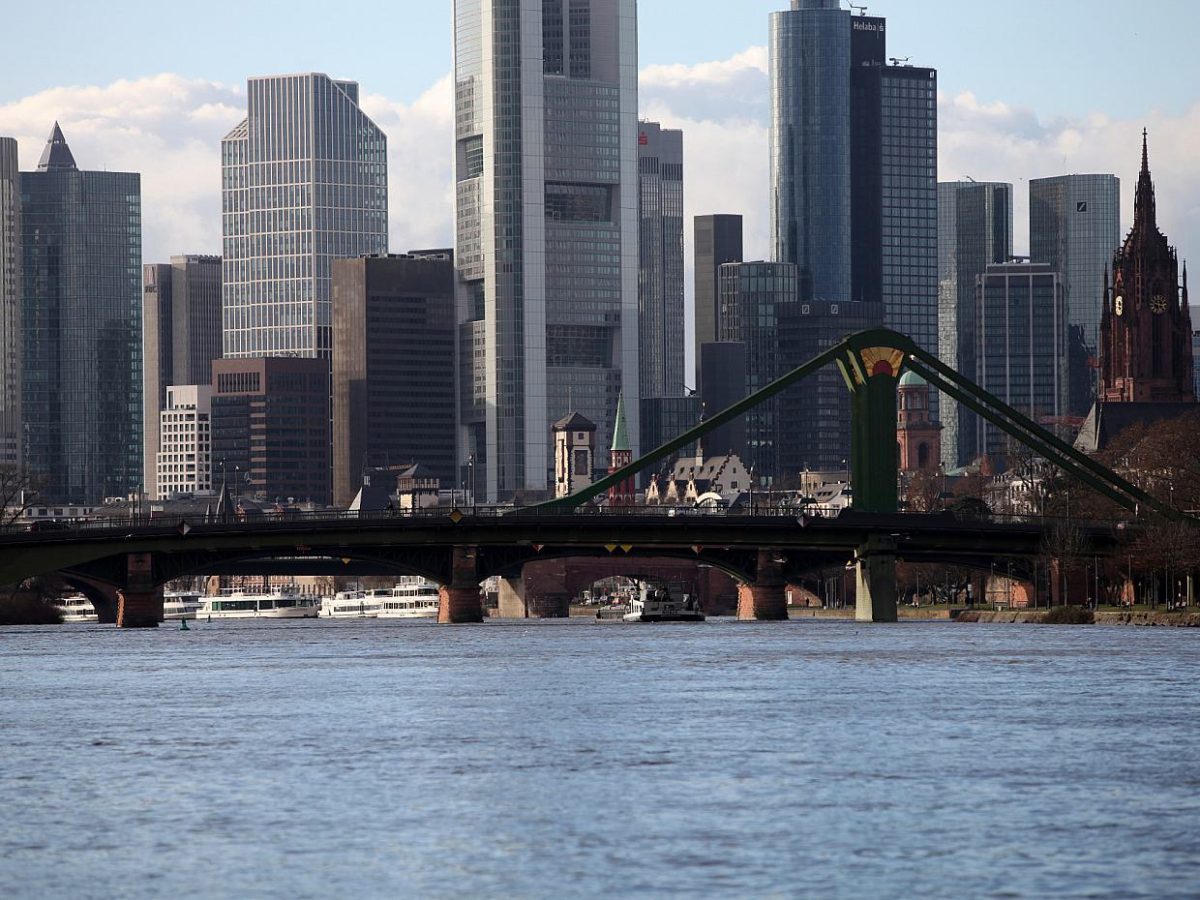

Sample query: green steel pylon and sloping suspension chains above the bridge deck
[542,328,1187,520]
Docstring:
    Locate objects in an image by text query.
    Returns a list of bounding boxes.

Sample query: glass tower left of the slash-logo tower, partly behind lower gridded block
[937,181,1013,469]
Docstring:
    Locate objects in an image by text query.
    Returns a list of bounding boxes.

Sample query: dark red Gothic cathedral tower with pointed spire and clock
[1076,133,1196,452]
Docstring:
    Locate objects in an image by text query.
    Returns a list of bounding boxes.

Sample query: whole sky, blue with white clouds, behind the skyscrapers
[0,0,1200,372]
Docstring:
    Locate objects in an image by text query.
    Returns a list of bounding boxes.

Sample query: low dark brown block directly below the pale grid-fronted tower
[212,358,330,503]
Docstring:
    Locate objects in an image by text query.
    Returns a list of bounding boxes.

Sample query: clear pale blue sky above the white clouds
[9,0,1200,116]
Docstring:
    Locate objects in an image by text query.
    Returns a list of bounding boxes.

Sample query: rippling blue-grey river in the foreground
[0,620,1200,900]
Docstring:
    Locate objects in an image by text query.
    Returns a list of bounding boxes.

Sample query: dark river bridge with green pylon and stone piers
[0,329,1182,628]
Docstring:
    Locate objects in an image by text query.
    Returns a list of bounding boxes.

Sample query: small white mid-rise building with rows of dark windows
[152,384,214,500]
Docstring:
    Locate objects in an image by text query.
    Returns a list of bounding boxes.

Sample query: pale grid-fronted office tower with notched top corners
[221,73,388,358]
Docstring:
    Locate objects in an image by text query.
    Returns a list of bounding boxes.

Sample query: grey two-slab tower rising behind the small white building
[142,256,221,498]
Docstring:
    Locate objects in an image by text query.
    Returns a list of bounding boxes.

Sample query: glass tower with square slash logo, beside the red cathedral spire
[1030,175,1121,416]
